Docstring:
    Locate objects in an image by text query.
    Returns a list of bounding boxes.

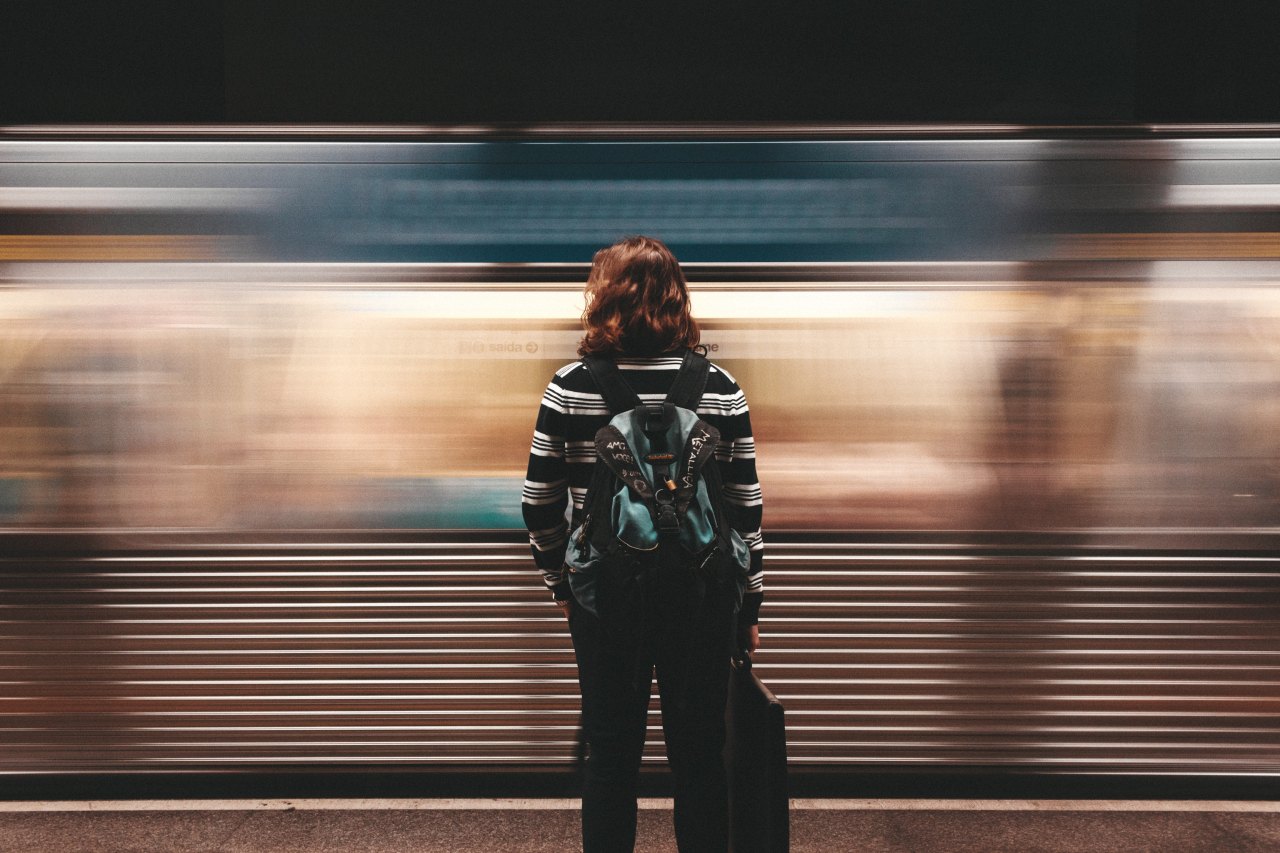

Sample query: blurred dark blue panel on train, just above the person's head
[288,143,1023,263]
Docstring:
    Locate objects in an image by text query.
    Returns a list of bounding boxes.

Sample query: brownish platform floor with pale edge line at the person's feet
[0,799,1280,853]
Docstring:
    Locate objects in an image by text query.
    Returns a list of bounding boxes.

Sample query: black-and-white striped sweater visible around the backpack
[521,355,764,625]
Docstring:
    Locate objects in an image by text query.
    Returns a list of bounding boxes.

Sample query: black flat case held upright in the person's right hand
[724,654,791,853]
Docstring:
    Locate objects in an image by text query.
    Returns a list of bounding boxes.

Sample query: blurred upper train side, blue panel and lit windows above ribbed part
[0,128,1280,530]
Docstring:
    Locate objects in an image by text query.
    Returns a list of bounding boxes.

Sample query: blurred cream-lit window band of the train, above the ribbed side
[0,261,1280,530]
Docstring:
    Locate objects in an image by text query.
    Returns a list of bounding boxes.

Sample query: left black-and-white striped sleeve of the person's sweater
[521,375,568,596]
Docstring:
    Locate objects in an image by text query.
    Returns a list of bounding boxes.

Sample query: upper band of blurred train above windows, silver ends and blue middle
[0,138,1239,264]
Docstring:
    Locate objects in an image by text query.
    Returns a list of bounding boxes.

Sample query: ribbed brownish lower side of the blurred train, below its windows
[0,532,1280,775]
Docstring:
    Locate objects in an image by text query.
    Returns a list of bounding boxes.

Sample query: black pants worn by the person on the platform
[570,560,736,853]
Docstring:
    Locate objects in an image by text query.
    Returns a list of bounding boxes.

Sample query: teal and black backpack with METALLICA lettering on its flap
[564,351,750,633]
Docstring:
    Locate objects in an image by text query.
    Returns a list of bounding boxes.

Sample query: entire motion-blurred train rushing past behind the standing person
[0,128,1280,775]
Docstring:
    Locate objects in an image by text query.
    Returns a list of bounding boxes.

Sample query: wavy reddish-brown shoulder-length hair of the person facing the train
[577,237,701,356]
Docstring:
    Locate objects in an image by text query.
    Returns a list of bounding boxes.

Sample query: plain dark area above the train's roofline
[0,0,1280,126]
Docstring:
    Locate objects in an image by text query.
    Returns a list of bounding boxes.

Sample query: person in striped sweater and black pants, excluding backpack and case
[522,237,764,853]
